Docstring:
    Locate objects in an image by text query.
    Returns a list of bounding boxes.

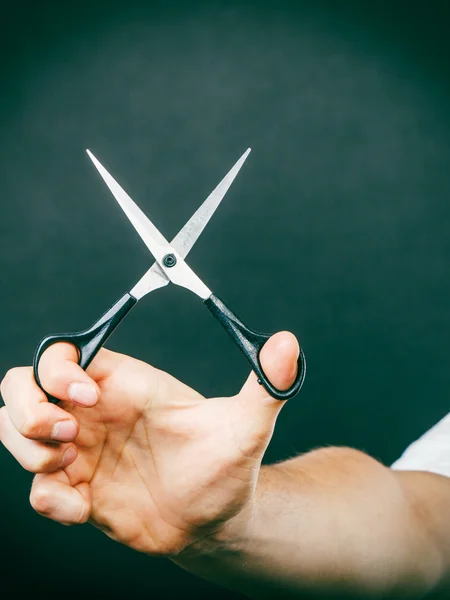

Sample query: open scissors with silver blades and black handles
[33,148,306,402]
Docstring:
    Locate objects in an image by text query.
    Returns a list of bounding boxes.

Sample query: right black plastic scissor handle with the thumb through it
[205,294,306,400]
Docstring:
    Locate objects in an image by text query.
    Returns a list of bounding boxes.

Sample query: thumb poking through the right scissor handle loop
[239,331,300,416]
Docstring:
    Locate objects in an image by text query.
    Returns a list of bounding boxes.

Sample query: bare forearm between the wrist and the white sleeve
[175,448,450,598]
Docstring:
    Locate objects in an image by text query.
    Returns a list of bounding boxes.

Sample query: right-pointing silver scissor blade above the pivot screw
[171,148,251,258]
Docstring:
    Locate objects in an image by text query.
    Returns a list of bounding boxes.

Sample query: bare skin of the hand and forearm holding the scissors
[0,332,450,600]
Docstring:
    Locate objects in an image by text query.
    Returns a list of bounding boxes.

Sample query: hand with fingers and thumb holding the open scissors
[0,332,298,556]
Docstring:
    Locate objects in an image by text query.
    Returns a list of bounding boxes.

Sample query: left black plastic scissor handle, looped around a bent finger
[33,293,137,403]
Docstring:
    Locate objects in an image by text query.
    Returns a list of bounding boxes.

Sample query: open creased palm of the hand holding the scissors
[53,358,265,554]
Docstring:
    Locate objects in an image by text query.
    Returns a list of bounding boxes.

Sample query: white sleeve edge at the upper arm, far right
[391,413,450,477]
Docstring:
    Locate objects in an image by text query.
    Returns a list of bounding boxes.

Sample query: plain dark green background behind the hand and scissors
[0,0,450,599]
